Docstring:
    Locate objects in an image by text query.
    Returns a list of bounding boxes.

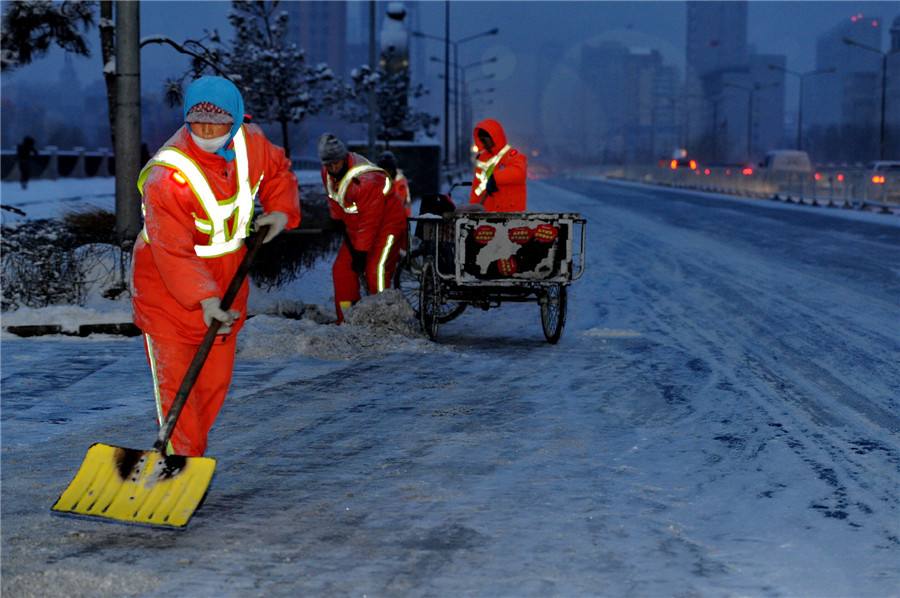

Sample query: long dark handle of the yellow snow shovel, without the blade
[153,225,269,455]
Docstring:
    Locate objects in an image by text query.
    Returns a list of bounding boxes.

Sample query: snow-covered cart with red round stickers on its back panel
[398,197,585,343]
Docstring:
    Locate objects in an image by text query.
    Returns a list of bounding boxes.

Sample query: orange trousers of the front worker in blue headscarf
[144,334,237,457]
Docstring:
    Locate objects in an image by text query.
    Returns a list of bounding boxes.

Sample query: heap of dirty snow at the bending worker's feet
[238,289,439,360]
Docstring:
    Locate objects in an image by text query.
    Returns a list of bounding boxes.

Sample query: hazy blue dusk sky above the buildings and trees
[2,0,900,148]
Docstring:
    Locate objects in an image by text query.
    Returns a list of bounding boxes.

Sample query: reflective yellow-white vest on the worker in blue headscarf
[138,127,263,258]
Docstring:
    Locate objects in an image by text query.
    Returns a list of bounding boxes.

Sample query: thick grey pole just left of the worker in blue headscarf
[115,1,142,249]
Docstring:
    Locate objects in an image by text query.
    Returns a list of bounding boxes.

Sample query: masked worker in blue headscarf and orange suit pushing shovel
[132,77,300,456]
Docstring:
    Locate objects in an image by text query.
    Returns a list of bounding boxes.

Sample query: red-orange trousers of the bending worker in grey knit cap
[331,230,406,323]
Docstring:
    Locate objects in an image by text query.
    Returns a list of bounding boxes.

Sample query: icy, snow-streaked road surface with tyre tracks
[2,180,900,597]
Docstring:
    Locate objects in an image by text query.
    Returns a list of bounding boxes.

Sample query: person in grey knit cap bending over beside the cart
[318,133,406,324]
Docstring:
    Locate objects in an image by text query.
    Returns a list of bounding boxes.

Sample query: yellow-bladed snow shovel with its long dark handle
[51,226,268,528]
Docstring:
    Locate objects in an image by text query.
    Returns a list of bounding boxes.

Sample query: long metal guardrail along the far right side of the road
[602,165,900,213]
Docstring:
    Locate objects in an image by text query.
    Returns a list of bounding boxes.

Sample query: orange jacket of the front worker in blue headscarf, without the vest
[132,124,300,344]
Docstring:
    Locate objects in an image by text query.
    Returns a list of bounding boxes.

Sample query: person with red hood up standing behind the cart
[469,118,528,212]
